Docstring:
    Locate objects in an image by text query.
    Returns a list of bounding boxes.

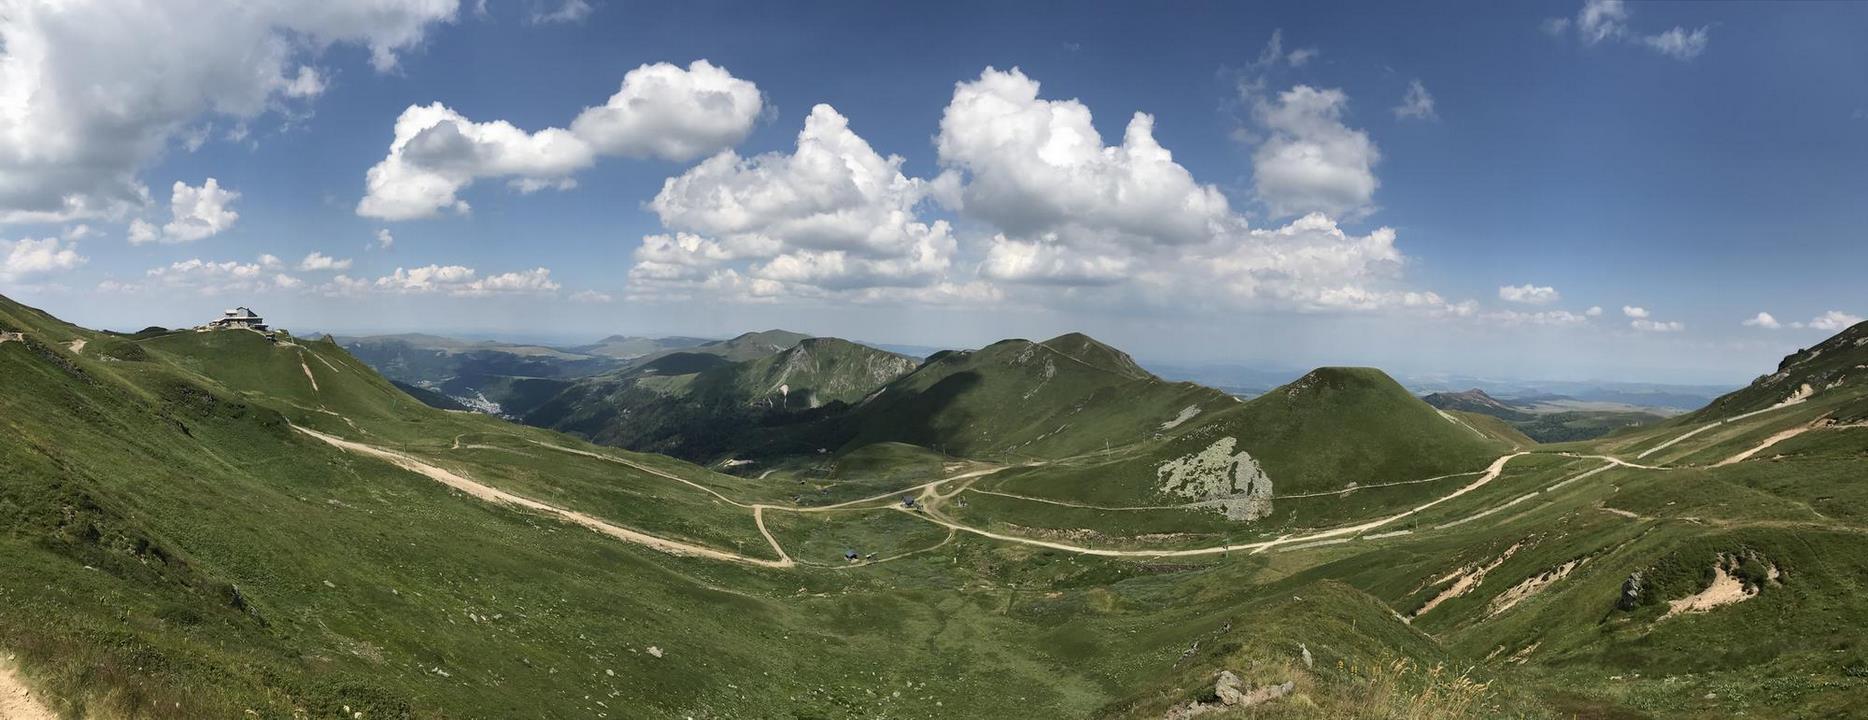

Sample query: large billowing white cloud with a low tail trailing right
[934,67,1412,310]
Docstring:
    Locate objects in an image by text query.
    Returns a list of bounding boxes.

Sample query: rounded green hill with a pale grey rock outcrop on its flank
[948,368,1515,544]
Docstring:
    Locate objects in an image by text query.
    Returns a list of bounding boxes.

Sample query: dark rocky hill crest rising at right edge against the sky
[1679,322,1868,425]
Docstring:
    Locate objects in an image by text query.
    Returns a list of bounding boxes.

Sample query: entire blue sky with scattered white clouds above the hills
[0,0,1868,382]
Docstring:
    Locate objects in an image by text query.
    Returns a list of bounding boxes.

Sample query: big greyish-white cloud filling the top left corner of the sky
[0,0,456,223]
